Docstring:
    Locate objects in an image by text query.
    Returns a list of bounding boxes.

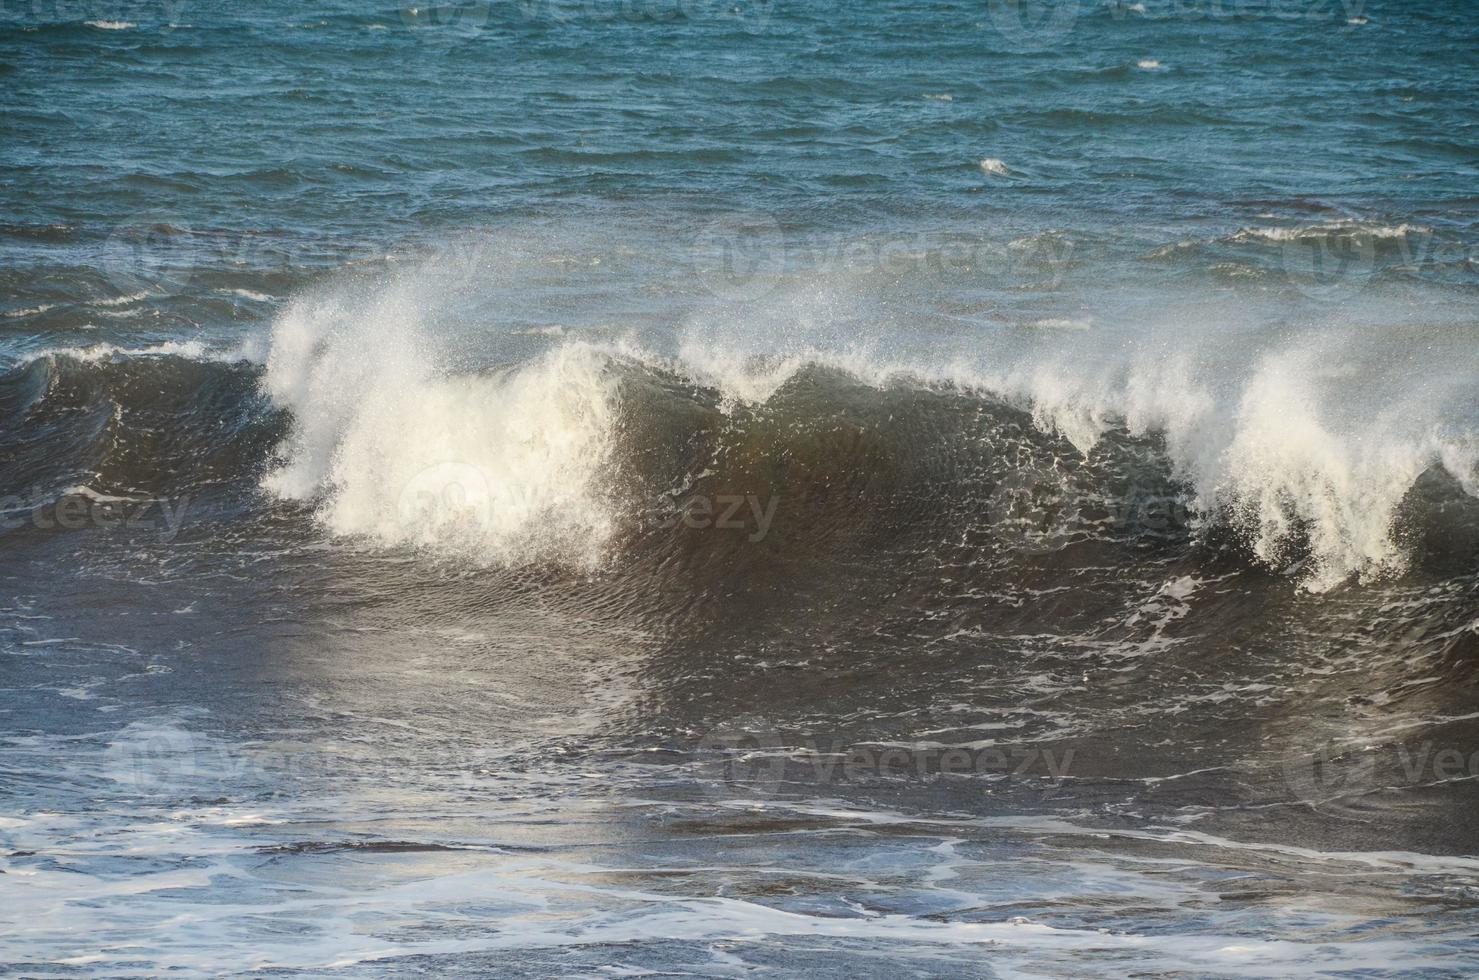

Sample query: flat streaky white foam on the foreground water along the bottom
[0,762,1475,977]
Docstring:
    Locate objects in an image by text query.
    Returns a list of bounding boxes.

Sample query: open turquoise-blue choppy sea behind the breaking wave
[0,0,1479,317]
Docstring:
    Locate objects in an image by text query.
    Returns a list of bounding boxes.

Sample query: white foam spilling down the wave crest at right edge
[992,341,1479,590]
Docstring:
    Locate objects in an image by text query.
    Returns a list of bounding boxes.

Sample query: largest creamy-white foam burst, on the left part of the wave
[265,277,615,568]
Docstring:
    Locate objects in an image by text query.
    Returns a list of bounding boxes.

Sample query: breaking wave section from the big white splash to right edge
[242,249,1479,591]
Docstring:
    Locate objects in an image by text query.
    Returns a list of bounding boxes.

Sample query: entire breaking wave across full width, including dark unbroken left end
[4,238,1479,603]
